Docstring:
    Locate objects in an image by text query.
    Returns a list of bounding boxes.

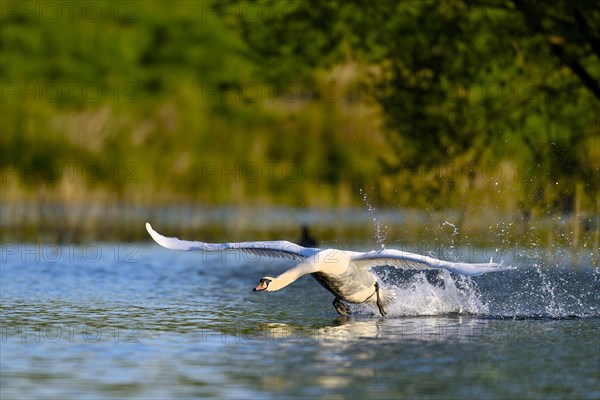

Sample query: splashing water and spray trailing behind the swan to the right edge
[353,265,600,319]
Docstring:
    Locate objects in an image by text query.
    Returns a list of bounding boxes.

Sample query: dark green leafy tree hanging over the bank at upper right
[231,0,600,210]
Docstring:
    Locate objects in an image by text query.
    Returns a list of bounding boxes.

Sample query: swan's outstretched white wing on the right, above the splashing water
[351,249,514,276]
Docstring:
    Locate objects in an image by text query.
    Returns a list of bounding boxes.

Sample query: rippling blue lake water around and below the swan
[0,243,600,400]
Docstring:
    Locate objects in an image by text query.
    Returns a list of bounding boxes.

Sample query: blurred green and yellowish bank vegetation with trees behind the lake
[0,0,600,248]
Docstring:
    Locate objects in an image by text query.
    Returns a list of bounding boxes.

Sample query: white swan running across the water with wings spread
[146,223,513,316]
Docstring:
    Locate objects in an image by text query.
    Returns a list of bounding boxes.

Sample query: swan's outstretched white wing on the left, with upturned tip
[146,222,320,260]
